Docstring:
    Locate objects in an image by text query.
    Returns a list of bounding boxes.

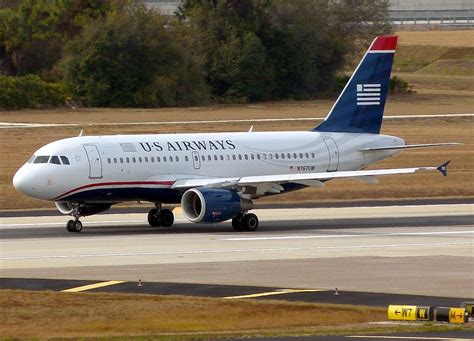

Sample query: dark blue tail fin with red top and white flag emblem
[313,36,398,134]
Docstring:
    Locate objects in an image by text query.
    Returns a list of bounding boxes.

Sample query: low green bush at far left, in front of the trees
[0,75,65,110]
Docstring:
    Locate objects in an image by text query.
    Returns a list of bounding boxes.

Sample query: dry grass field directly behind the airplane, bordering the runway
[0,115,474,209]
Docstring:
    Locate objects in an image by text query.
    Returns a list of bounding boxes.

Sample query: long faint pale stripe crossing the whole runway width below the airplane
[0,242,474,261]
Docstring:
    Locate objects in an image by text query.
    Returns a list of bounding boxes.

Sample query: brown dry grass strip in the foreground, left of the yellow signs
[0,290,386,338]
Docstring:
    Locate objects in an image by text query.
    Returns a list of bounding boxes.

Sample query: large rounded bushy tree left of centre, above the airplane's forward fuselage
[64,2,206,107]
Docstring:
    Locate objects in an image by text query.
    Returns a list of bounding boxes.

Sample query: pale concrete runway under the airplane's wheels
[0,204,474,298]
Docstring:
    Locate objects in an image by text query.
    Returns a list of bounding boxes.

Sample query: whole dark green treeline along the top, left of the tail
[0,0,390,108]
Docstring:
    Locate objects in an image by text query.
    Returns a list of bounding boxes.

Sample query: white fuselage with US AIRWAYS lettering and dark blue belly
[14,131,405,203]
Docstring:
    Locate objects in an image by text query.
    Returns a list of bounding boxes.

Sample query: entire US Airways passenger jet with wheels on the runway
[13,36,456,232]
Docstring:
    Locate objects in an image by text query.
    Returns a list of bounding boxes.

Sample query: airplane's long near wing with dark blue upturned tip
[171,161,450,194]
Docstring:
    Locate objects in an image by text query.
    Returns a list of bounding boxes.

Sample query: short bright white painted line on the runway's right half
[222,231,474,241]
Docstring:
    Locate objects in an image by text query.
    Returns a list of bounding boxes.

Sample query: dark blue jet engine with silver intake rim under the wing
[181,187,253,223]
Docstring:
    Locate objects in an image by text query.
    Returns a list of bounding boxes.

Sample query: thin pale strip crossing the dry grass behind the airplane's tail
[0,113,474,129]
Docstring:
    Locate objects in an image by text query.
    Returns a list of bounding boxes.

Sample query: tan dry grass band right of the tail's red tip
[396,30,474,47]
